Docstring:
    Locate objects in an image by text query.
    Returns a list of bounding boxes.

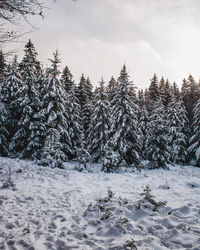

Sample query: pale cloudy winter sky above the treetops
[5,0,200,89]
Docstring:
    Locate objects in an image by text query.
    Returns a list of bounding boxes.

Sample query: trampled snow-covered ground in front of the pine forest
[0,158,200,250]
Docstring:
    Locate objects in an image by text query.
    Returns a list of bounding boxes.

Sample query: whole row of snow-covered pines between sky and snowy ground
[0,40,200,172]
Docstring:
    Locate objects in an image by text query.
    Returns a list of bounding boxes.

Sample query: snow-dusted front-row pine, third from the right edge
[146,102,170,169]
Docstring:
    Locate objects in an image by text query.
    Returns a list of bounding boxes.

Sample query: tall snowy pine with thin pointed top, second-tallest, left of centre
[38,51,70,167]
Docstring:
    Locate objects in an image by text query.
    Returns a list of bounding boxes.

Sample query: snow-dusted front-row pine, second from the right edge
[167,98,189,164]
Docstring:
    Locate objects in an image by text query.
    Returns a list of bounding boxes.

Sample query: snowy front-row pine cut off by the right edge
[189,100,200,167]
